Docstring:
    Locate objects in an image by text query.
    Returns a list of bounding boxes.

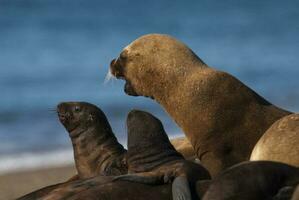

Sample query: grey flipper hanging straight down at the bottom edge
[172,176,192,200]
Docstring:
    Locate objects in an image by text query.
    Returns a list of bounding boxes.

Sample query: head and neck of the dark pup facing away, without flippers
[127,110,183,172]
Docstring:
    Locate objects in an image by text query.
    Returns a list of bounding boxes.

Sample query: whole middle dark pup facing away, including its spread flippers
[114,110,210,200]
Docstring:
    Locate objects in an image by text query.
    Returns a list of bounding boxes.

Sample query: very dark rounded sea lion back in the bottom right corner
[198,161,299,200]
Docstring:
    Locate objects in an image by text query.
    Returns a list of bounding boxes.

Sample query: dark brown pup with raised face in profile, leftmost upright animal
[57,102,127,179]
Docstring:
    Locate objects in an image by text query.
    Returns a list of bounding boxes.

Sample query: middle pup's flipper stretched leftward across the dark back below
[113,172,160,184]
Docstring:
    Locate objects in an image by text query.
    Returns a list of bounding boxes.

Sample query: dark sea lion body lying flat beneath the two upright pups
[18,176,172,200]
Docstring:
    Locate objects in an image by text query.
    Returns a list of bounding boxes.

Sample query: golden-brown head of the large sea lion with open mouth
[110,34,205,98]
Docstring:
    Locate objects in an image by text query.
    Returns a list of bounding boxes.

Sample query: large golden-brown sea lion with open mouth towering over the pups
[110,34,290,175]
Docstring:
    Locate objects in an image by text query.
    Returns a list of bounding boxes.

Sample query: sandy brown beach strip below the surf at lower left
[0,165,75,200]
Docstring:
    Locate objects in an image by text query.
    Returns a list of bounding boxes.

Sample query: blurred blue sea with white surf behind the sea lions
[0,0,299,174]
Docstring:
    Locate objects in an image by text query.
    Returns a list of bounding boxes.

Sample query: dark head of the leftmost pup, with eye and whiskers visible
[57,102,111,136]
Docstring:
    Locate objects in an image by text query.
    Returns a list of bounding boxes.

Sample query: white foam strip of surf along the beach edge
[0,149,74,174]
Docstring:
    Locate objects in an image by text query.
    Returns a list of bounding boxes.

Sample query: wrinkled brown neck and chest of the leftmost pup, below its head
[71,119,126,178]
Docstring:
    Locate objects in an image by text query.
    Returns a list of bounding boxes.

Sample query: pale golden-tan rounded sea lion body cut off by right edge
[250,114,299,167]
